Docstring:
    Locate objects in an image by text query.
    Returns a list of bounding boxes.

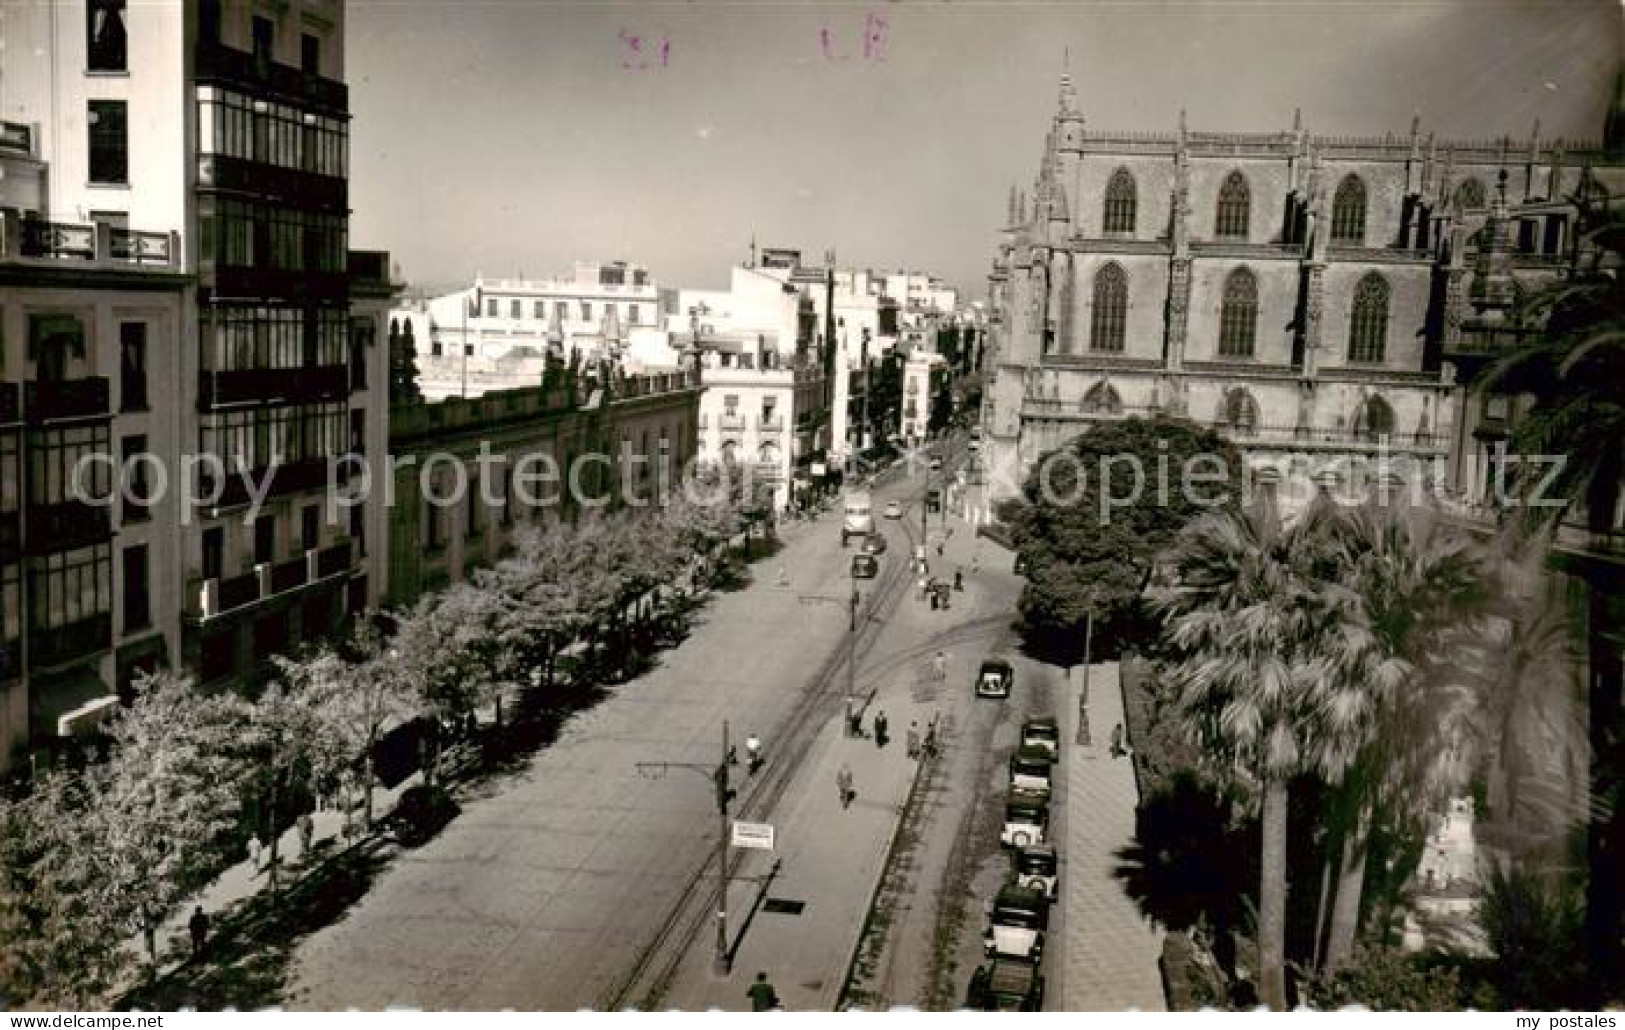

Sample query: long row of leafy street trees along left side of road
[0,467,744,1009]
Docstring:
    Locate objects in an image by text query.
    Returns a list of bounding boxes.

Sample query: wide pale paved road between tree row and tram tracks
[288,517,847,1011]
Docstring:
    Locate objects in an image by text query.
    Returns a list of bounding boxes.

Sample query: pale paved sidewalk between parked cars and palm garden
[1060,661,1167,1012]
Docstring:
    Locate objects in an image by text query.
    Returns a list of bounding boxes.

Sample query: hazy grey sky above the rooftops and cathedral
[346,0,1625,299]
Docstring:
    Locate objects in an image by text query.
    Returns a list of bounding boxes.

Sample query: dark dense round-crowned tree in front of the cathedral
[1006,418,1242,664]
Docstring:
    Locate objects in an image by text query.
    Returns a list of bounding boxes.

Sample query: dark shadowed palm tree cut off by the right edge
[1482,197,1625,985]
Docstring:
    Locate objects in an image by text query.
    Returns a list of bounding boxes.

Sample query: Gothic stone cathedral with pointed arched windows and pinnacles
[982,63,1625,500]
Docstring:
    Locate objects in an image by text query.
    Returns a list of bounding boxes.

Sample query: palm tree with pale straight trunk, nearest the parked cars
[1155,504,1347,1011]
